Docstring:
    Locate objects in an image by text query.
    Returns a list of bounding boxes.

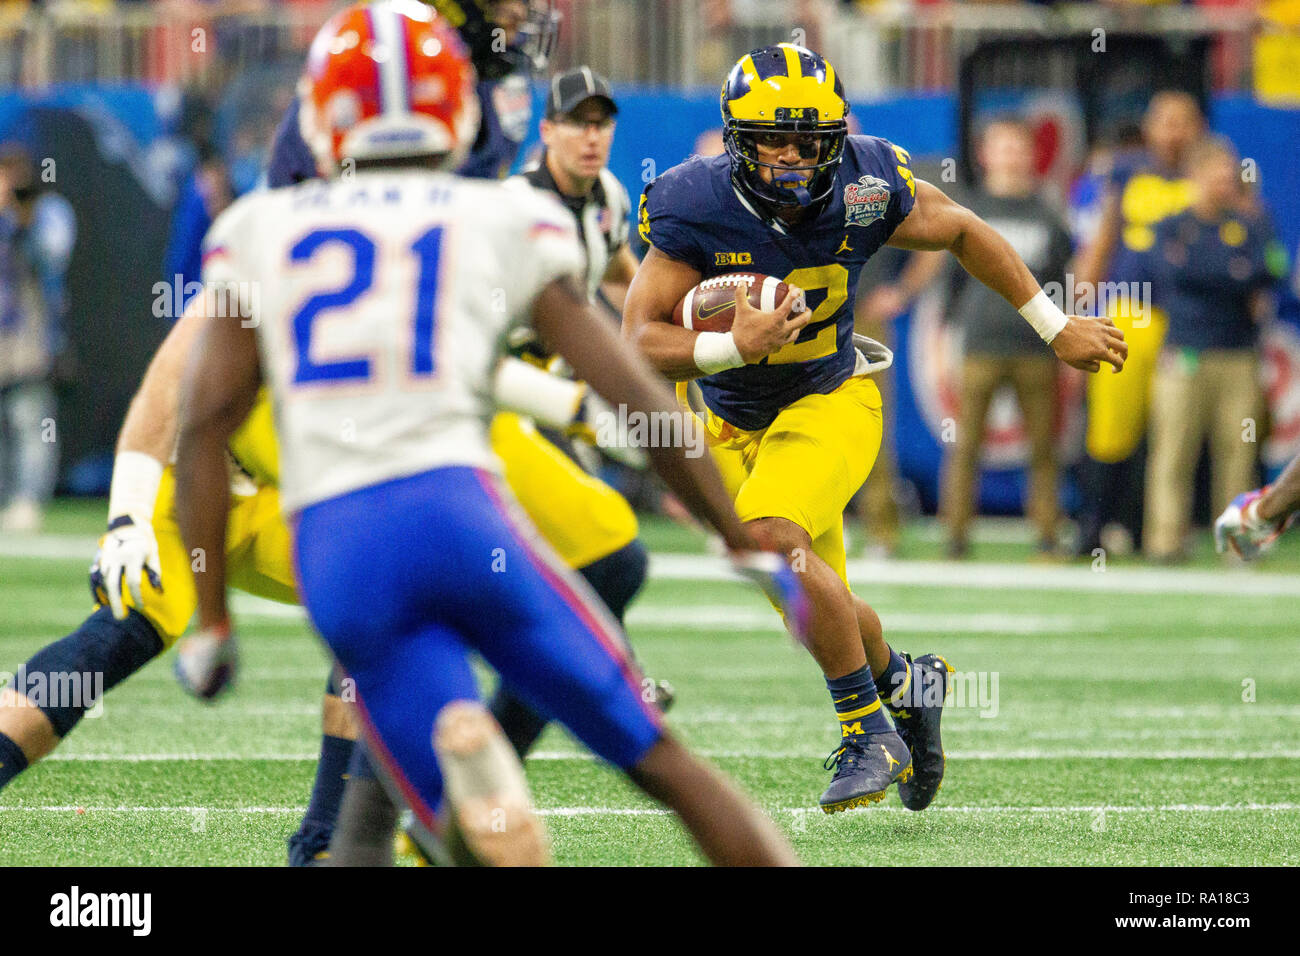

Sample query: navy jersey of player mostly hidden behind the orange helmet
[267,73,533,189]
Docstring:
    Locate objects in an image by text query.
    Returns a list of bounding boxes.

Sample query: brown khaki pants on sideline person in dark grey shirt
[940,355,1058,541]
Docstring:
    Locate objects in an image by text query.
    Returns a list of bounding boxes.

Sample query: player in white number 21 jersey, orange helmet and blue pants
[176,0,806,864]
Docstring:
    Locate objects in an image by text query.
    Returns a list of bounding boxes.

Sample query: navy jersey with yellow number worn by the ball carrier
[640,137,917,431]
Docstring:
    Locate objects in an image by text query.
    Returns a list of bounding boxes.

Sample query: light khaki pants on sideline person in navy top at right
[1144,349,1261,558]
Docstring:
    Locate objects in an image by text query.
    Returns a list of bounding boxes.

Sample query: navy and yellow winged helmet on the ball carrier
[722,43,849,215]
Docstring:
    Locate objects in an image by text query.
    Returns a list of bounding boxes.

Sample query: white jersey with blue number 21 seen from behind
[203,170,584,511]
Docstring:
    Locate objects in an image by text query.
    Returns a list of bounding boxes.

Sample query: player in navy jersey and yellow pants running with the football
[624,43,1127,813]
